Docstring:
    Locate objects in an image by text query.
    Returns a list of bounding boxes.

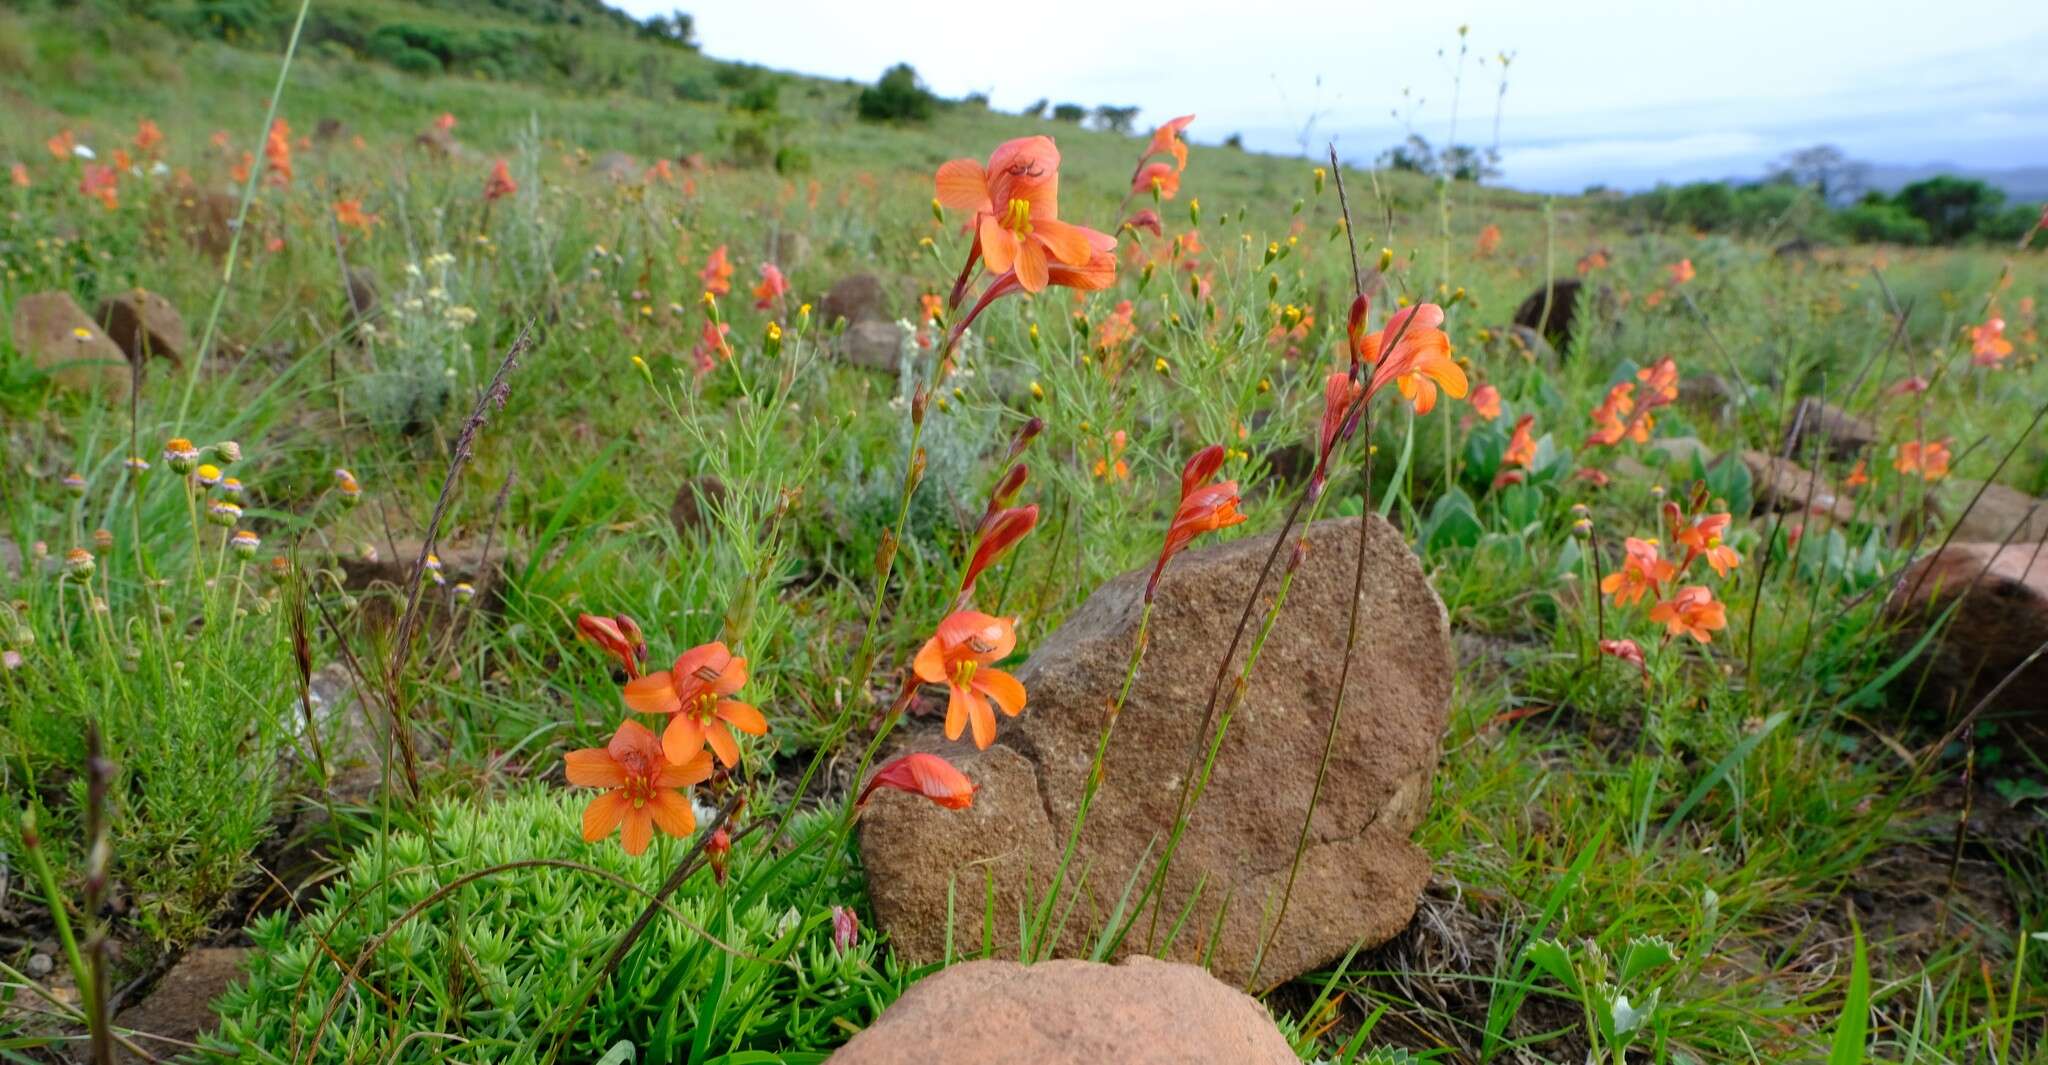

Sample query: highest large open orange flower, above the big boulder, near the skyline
[936,137,1116,293]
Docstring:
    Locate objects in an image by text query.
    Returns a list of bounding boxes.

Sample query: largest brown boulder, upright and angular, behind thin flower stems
[860,518,1452,985]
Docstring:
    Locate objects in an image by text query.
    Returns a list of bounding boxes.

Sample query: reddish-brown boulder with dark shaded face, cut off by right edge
[1884,543,2048,741]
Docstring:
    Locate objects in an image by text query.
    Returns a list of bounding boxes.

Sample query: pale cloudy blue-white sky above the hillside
[612,0,2048,193]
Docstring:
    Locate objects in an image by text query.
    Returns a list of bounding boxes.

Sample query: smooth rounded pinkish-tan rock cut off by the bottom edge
[827,956,1298,1065]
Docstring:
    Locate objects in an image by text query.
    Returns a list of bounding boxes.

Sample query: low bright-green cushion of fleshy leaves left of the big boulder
[211,791,909,1061]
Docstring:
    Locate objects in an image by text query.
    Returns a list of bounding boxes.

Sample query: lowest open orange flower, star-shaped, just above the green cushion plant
[561,721,711,854]
